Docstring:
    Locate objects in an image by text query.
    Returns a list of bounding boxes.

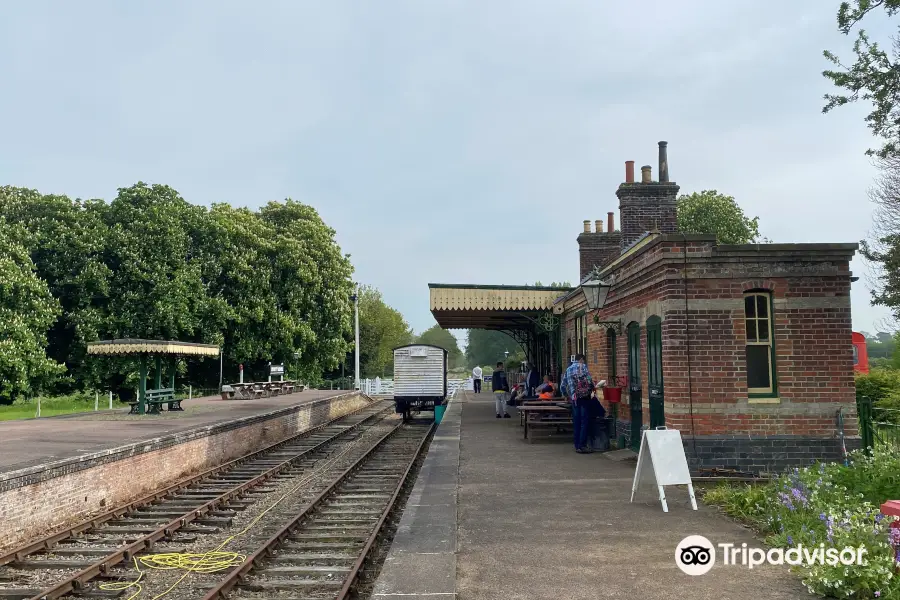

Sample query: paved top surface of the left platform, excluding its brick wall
[0,390,347,474]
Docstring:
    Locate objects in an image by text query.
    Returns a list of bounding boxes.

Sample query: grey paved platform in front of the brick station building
[374,392,813,600]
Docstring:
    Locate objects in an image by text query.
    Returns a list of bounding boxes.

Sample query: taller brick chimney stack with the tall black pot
[616,142,679,252]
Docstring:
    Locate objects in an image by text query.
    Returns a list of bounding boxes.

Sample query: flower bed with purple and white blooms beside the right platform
[704,450,900,600]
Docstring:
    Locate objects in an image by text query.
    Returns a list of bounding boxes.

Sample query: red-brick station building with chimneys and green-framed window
[553,142,859,472]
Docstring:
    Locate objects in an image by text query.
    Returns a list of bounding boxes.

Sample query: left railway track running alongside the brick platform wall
[0,402,392,600]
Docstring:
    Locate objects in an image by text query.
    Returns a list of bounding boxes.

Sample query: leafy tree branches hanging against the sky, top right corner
[822,0,900,159]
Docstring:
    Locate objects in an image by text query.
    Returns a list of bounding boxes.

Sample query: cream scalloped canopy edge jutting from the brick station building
[428,283,571,331]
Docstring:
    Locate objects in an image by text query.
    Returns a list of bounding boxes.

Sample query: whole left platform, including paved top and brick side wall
[0,390,373,551]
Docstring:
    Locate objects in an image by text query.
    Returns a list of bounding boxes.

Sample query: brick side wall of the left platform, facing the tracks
[0,392,371,551]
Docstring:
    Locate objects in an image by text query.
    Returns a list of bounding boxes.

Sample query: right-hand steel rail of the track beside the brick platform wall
[22,404,383,600]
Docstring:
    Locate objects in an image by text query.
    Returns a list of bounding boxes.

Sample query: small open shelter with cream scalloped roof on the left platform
[87,339,221,415]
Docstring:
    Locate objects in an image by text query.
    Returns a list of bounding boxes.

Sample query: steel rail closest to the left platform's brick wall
[0,402,387,567]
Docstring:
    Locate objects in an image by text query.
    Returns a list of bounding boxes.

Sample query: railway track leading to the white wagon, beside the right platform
[203,421,433,600]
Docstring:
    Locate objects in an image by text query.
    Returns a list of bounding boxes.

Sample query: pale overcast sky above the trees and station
[0,0,887,346]
